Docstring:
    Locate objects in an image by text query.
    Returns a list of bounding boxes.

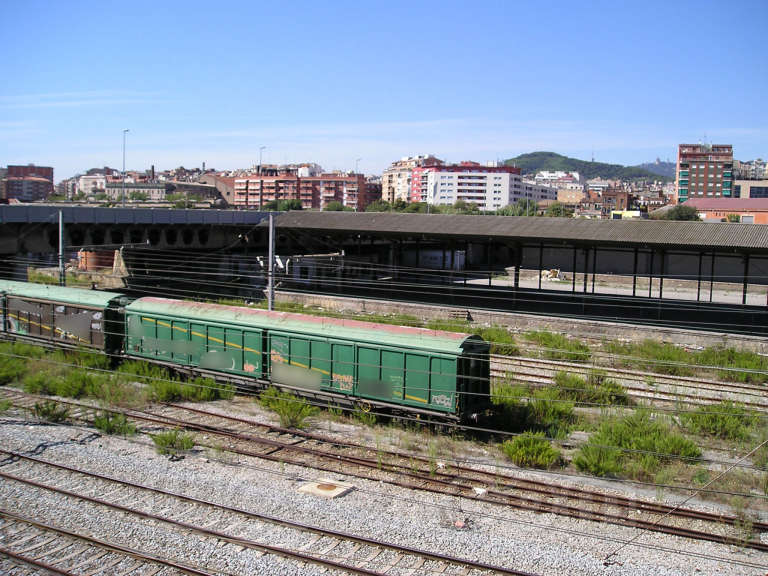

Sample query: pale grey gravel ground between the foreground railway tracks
[0,412,768,576]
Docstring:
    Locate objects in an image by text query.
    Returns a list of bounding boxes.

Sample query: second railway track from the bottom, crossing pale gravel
[0,450,532,576]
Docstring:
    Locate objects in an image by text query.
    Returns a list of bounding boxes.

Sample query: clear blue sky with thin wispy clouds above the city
[0,0,768,180]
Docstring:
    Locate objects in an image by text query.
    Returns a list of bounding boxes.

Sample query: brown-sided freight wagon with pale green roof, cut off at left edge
[0,280,127,354]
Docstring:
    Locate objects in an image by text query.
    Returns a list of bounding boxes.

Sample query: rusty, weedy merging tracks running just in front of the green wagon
[3,390,768,551]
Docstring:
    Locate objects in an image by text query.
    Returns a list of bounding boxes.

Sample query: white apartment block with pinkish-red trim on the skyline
[421,169,557,211]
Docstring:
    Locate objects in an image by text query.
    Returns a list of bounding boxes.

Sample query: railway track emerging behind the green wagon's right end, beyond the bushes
[491,354,768,413]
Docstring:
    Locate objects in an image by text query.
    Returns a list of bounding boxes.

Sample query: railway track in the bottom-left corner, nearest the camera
[0,510,217,576]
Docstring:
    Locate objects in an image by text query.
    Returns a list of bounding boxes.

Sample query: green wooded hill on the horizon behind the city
[504,152,669,180]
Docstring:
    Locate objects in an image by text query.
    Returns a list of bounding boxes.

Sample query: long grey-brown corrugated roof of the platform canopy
[272,211,768,251]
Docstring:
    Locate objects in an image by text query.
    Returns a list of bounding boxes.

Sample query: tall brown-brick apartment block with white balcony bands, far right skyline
[675,144,733,203]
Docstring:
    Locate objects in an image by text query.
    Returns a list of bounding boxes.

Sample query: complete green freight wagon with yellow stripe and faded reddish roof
[125,298,489,418]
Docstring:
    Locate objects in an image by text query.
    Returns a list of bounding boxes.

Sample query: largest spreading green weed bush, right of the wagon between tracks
[573,410,701,480]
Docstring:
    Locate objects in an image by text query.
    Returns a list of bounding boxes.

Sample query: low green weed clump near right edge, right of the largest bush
[680,401,760,440]
